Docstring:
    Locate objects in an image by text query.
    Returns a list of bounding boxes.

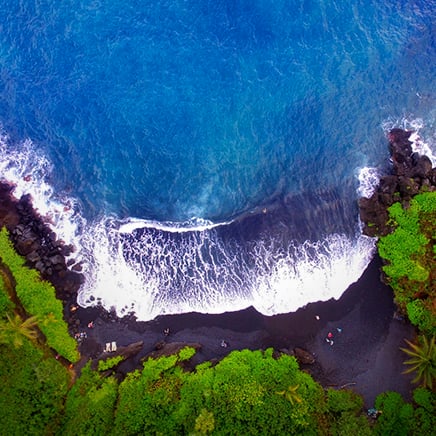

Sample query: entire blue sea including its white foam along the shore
[0,0,436,320]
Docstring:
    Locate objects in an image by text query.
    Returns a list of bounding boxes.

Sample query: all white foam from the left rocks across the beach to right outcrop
[0,127,416,320]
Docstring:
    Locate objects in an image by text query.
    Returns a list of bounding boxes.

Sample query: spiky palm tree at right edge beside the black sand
[400,335,436,389]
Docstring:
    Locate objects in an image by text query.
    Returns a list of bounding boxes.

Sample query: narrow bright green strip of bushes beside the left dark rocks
[0,228,79,362]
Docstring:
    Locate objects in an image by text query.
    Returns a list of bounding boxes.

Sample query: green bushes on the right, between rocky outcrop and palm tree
[378,192,436,336]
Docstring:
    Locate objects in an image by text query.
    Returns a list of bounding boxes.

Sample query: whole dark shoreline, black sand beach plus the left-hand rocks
[0,179,415,408]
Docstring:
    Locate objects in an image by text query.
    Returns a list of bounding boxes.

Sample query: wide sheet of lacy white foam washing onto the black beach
[78,215,375,320]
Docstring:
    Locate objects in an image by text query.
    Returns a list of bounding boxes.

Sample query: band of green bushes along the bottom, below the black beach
[4,341,436,436]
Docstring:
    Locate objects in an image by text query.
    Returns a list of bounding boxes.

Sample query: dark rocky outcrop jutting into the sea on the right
[359,129,436,236]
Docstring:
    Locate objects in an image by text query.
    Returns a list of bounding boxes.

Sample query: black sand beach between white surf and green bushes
[75,257,415,408]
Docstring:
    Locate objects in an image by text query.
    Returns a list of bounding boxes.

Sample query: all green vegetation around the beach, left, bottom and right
[0,204,436,436]
